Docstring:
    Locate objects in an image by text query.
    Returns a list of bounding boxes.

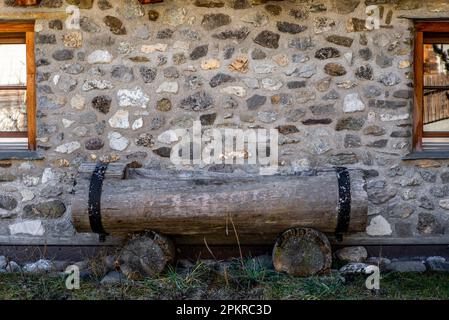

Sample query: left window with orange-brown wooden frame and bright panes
[0,22,36,153]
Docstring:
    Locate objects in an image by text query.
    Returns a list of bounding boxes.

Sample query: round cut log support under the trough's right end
[273,228,332,277]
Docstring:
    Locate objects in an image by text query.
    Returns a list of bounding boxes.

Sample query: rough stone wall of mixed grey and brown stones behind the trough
[0,0,449,243]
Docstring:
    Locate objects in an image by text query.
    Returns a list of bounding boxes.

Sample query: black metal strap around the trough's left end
[88,162,108,242]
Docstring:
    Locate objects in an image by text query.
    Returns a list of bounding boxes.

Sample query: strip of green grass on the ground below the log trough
[0,260,449,300]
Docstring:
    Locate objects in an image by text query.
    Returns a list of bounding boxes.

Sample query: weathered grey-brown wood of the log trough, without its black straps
[72,169,367,236]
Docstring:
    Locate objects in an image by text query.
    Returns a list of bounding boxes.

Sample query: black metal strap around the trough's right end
[335,167,351,238]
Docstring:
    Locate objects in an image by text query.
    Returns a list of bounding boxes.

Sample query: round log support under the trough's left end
[119,231,175,280]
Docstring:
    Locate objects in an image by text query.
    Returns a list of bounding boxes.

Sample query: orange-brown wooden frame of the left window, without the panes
[0,21,36,152]
